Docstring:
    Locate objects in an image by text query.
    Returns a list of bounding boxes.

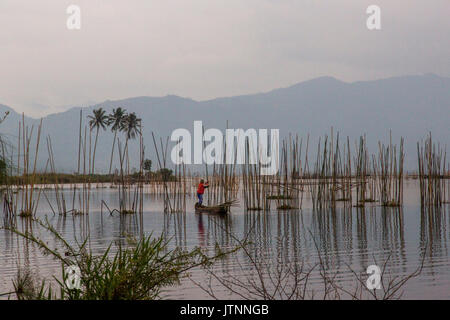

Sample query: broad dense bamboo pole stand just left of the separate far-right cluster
[309,133,405,208]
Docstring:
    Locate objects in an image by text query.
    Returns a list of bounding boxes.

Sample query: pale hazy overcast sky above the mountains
[0,0,450,116]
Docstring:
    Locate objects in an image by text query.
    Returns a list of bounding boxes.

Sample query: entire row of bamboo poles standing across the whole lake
[2,116,450,221]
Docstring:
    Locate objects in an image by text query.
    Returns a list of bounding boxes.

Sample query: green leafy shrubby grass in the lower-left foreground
[4,220,237,300]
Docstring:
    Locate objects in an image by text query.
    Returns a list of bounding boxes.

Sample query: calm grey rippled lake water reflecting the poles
[0,180,450,299]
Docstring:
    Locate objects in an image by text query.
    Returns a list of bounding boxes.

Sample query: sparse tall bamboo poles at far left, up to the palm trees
[2,111,144,235]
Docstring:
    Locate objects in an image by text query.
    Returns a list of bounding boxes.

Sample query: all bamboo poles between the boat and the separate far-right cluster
[241,131,405,210]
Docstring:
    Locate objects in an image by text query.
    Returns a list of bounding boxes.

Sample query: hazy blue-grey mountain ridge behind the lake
[0,74,450,172]
